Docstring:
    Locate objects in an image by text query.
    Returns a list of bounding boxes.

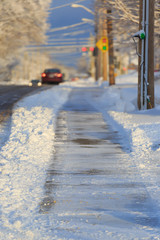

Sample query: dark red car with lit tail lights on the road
[41,68,63,84]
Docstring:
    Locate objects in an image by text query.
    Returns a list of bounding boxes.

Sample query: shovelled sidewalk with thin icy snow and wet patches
[40,89,159,239]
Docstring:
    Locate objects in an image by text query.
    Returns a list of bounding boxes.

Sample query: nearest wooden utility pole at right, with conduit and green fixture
[138,0,155,110]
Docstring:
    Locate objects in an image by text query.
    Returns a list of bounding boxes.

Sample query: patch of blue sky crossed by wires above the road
[47,0,94,67]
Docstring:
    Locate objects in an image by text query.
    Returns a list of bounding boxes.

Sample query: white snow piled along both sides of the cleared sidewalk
[0,72,160,240]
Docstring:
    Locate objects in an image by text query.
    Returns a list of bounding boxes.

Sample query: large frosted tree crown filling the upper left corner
[0,0,51,81]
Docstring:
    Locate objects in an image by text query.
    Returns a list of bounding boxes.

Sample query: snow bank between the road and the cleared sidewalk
[0,87,70,240]
